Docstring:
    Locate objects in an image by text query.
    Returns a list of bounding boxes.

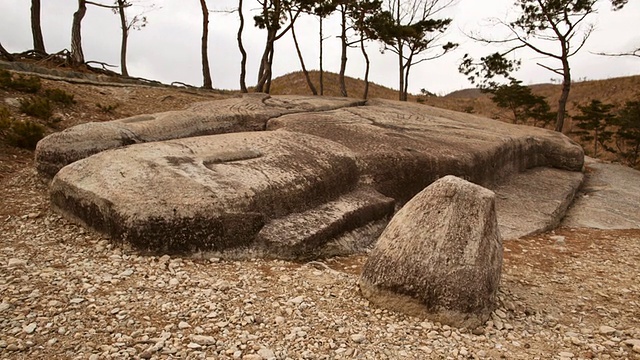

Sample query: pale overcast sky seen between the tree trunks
[0,0,640,95]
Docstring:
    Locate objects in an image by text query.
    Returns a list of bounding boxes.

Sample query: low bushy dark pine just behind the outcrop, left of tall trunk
[483,79,555,127]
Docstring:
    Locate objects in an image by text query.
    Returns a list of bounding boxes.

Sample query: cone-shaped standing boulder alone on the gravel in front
[360,176,502,328]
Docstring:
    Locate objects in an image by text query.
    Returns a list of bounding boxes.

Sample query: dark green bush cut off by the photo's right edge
[614,101,640,167]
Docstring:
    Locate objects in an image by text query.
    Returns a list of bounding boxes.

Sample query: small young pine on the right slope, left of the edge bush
[573,100,615,157]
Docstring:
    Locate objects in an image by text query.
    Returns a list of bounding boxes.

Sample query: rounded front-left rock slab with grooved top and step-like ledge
[51,131,393,258]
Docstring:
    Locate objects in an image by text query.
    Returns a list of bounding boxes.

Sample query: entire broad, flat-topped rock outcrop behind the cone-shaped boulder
[43,94,584,259]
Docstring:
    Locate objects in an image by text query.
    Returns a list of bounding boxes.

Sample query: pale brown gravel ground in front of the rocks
[0,164,640,360]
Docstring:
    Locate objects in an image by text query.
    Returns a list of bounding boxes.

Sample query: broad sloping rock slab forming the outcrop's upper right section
[267,100,584,204]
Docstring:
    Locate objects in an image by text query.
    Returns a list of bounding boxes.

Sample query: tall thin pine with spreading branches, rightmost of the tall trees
[460,0,600,132]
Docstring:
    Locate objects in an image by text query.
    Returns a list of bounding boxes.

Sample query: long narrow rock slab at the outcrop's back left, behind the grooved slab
[35,94,362,178]
